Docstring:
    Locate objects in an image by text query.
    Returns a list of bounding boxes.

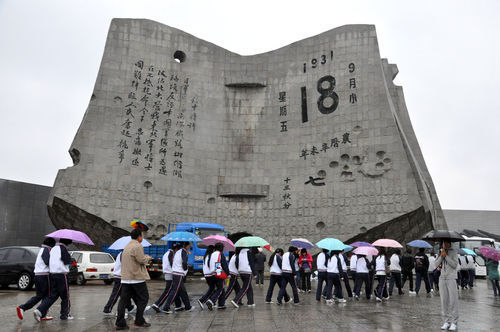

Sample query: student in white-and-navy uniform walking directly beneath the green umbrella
[231,248,256,308]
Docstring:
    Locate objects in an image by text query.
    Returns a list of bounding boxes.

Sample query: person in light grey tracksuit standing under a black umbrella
[435,240,458,331]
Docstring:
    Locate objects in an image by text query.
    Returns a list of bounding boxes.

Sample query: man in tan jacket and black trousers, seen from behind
[115,228,153,330]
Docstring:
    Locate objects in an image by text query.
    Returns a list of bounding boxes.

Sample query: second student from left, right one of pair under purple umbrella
[33,239,73,321]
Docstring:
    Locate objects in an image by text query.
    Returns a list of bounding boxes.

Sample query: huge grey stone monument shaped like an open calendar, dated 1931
[48,19,446,247]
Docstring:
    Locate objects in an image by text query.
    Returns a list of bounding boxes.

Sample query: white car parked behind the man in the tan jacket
[70,251,115,285]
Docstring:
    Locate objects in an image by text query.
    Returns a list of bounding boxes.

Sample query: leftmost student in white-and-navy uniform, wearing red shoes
[16,237,56,320]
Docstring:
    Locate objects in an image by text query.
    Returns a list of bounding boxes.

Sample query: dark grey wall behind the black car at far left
[0,179,55,247]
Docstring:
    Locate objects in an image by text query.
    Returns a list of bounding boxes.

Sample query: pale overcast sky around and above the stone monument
[0,0,500,210]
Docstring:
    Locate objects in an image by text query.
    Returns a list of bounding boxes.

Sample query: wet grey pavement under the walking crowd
[0,277,500,332]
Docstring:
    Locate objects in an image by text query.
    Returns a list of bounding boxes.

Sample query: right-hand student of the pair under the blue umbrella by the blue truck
[163,242,193,314]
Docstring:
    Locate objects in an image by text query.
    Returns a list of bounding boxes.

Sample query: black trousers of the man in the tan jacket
[115,281,149,327]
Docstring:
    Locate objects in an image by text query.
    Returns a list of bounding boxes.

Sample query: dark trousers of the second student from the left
[37,273,71,319]
